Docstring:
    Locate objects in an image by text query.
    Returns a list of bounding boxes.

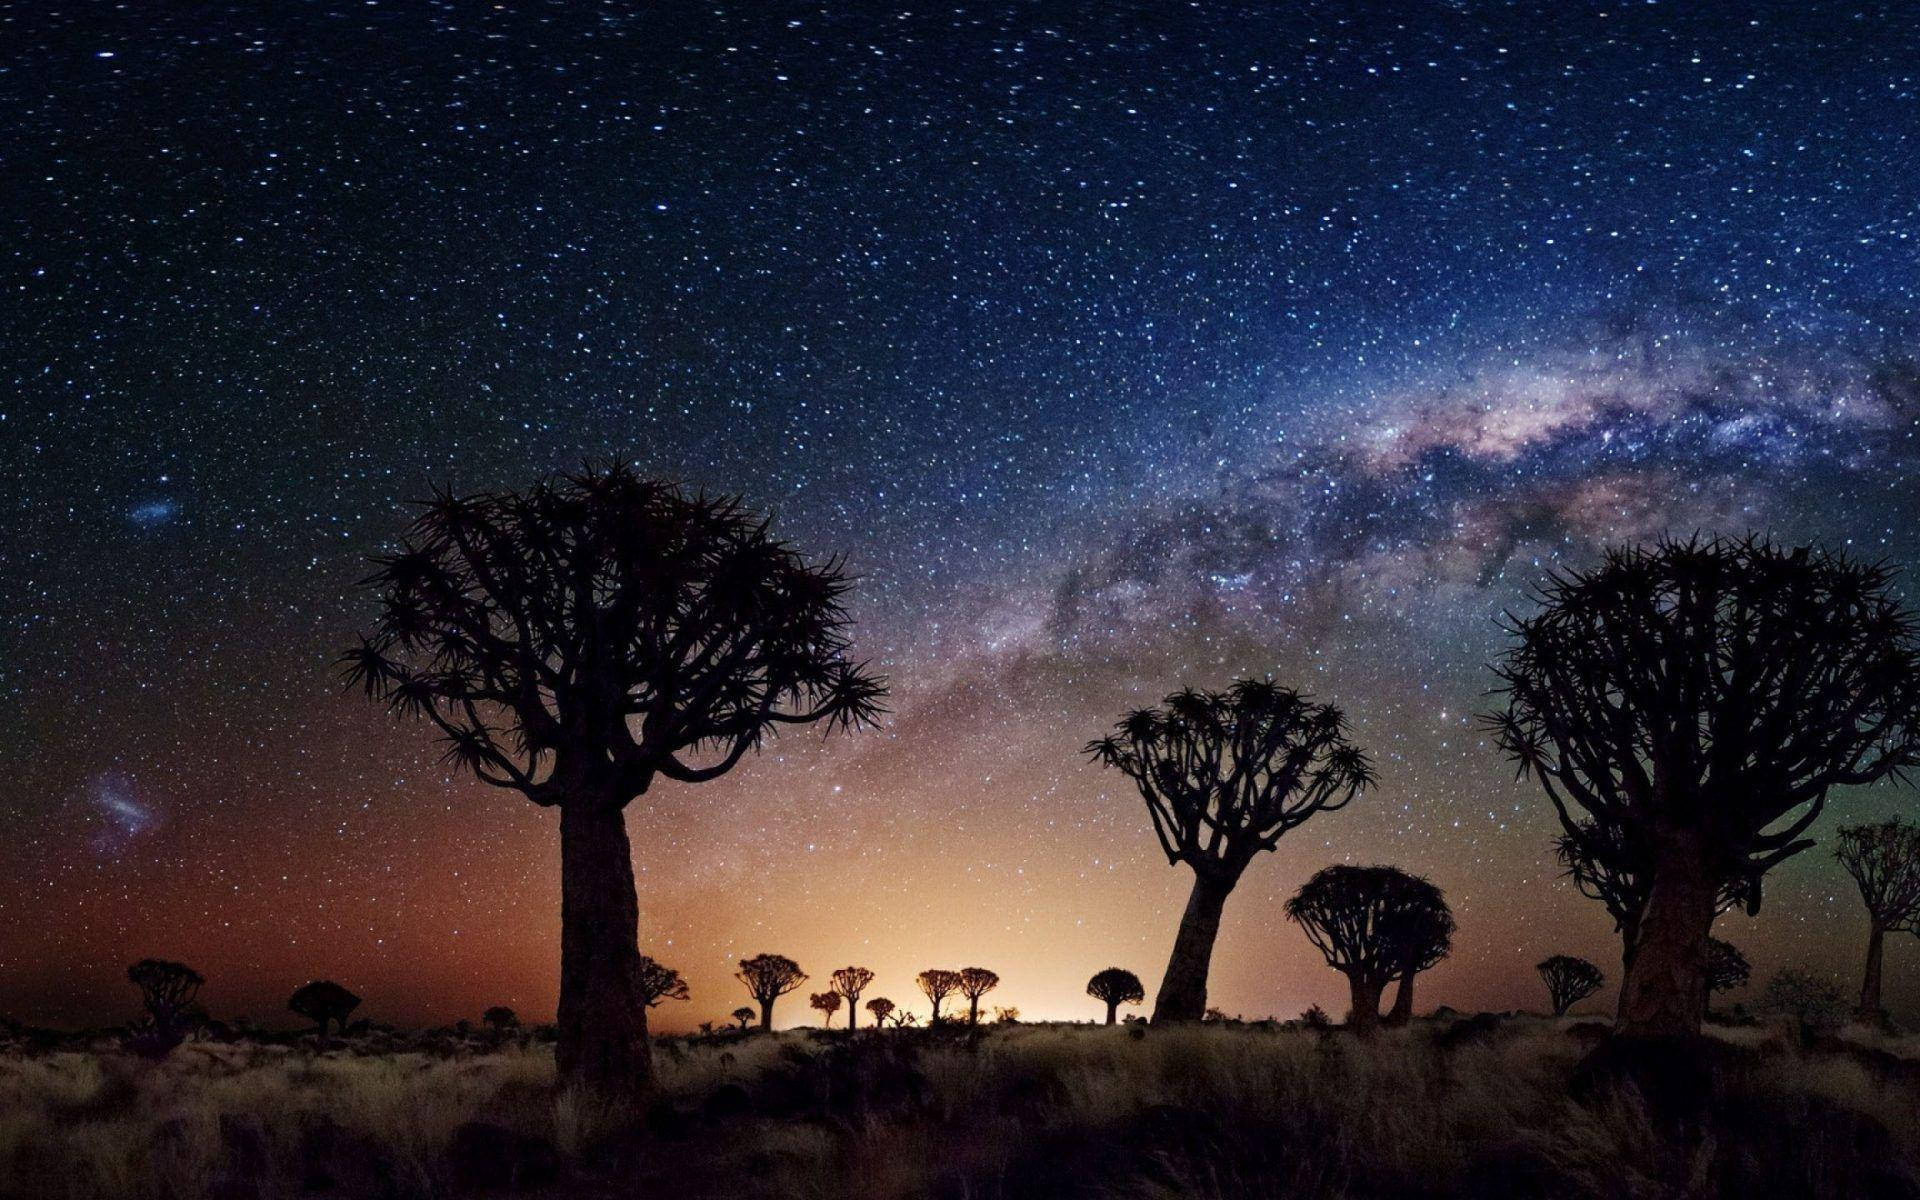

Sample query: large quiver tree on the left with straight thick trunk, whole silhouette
[342,465,885,1092]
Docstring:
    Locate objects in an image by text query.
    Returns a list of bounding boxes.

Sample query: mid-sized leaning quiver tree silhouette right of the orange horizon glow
[1087,680,1373,1021]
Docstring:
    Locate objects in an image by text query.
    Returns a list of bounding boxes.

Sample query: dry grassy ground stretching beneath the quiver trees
[0,1018,1920,1200]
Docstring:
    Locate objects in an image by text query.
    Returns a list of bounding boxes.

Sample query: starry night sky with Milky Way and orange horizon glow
[0,0,1920,1029]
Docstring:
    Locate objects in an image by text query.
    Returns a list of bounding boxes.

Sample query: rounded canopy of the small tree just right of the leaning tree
[1286,864,1453,983]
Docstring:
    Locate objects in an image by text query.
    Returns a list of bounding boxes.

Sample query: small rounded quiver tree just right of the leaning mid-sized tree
[1286,864,1444,1033]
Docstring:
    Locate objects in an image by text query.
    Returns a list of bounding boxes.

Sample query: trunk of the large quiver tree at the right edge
[1620,835,1718,1037]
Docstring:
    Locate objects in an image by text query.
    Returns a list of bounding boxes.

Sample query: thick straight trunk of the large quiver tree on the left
[553,799,653,1094]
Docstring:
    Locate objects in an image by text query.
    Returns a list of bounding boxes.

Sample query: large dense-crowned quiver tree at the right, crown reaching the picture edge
[1486,538,1920,1035]
